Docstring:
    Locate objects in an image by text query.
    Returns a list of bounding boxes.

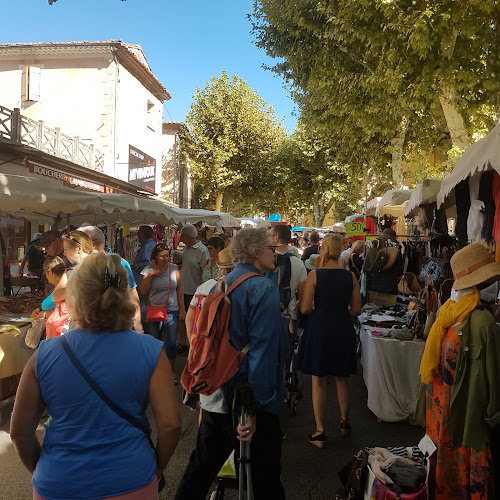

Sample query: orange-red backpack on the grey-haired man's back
[181,273,262,396]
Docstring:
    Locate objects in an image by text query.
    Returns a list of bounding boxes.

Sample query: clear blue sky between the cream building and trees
[0,0,296,132]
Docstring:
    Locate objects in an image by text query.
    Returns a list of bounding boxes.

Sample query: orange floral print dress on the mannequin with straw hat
[426,322,494,500]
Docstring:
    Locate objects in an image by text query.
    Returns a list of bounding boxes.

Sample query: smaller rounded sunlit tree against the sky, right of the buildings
[186,71,286,212]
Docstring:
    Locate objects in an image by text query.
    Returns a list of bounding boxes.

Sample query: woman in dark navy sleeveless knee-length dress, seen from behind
[297,236,361,448]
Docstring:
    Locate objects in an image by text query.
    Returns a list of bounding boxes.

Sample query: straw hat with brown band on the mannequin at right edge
[450,243,500,290]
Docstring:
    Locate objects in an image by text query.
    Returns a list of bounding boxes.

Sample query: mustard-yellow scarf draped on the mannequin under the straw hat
[420,287,481,384]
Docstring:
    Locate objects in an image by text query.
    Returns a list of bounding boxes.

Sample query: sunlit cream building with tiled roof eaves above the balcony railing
[0,40,170,194]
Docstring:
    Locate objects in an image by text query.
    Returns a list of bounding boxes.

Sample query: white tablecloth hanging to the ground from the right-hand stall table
[360,326,425,422]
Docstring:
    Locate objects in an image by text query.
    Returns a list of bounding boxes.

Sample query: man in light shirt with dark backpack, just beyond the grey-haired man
[269,224,307,373]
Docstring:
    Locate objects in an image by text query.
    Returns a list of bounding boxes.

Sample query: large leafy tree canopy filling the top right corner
[251,0,500,191]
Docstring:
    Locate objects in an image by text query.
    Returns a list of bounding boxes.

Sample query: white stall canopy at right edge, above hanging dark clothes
[437,123,500,207]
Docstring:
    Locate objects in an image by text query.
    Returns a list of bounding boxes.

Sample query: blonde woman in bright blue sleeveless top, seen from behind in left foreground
[11,254,180,500]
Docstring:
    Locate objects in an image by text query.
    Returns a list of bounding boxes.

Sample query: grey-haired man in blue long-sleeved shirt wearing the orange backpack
[174,228,287,500]
